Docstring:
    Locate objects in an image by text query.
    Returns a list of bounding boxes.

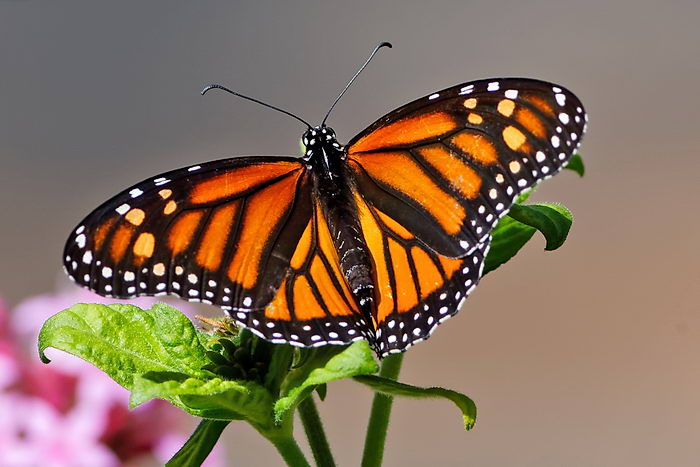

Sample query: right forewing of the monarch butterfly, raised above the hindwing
[346,78,586,257]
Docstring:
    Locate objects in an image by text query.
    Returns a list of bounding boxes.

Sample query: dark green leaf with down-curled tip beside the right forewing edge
[508,203,573,251]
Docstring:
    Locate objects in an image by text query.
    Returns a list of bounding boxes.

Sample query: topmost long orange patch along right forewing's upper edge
[348,112,457,154]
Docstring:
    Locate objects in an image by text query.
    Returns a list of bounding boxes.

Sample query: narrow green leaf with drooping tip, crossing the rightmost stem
[354,375,476,430]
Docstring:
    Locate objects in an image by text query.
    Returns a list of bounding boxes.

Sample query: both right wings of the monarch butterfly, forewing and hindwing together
[346,78,587,355]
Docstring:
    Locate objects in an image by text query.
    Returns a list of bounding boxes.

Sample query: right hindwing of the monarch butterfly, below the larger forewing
[356,188,491,356]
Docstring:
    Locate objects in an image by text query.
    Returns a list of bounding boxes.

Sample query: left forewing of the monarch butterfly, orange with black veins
[64,157,313,310]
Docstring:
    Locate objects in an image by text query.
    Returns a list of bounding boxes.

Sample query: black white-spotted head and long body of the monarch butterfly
[302,126,374,330]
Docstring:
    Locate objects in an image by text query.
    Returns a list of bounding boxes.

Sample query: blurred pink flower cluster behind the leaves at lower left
[0,290,224,467]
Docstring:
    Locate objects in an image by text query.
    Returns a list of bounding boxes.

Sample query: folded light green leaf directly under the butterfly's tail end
[275,340,379,423]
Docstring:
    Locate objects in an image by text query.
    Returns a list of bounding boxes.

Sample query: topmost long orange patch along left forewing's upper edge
[190,161,299,204]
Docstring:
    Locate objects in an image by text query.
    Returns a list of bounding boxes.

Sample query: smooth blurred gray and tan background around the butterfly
[0,0,700,466]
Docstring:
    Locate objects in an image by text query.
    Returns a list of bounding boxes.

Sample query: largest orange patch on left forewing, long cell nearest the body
[228,176,299,289]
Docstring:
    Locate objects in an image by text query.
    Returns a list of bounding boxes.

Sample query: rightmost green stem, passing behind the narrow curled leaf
[362,353,404,467]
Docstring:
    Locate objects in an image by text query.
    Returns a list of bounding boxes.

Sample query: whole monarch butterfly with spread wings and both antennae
[64,43,587,357]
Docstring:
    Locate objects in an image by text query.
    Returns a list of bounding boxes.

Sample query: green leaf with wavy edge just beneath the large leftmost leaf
[129,372,272,427]
